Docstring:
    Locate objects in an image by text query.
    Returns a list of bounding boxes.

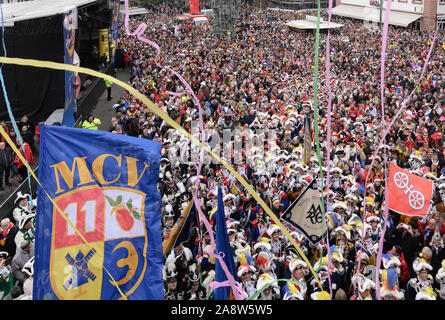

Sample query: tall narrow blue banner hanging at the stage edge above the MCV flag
[62,9,77,127]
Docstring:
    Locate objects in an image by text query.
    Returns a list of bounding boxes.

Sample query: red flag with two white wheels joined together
[388,163,433,216]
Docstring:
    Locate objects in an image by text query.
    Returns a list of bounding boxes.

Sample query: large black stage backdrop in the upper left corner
[0,14,64,122]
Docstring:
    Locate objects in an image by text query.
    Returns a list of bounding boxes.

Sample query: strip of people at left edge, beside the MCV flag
[0,120,40,300]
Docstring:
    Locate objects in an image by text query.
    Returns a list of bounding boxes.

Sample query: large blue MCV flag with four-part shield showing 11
[33,124,164,300]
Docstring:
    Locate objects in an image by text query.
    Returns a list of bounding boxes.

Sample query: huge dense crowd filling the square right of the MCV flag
[105,0,445,300]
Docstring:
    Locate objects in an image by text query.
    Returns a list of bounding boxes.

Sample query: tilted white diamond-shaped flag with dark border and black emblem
[281,180,326,244]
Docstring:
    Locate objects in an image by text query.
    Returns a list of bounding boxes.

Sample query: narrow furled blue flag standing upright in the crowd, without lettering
[214,186,237,300]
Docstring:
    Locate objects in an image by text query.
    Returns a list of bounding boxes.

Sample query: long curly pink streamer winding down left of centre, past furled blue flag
[125,0,244,300]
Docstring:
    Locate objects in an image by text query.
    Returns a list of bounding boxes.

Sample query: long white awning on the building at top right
[332,4,422,27]
